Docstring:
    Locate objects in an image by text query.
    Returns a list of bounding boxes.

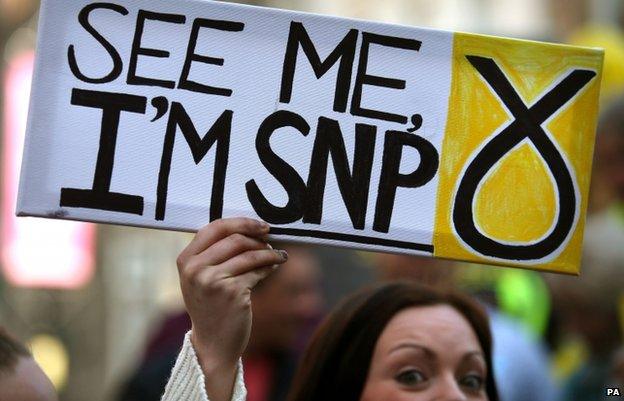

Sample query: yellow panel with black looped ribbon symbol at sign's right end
[434,33,603,274]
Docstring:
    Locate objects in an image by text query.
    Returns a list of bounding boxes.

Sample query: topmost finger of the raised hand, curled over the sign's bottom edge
[182,217,269,255]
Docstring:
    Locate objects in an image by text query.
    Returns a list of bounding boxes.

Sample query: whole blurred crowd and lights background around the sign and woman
[0,0,624,401]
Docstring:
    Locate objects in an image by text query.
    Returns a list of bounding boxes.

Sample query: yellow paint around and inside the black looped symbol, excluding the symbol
[434,33,603,274]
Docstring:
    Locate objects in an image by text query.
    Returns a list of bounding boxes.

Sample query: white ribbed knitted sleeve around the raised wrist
[161,331,247,401]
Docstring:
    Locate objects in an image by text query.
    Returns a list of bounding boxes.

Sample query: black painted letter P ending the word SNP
[373,131,439,233]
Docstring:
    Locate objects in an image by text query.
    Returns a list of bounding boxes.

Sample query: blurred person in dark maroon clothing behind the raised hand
[119,244,323,401]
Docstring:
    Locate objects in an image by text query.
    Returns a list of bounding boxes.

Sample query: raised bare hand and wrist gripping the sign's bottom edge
[177,218,288,401]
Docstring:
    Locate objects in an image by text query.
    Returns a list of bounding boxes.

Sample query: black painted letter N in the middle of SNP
[303,117,377,230]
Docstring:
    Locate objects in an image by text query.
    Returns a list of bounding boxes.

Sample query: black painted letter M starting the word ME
[280,21,358,113]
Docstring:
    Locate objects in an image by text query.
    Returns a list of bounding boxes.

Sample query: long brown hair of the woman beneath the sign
[288,283,498,401]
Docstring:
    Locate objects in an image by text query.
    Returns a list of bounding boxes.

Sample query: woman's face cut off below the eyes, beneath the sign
[360,305,489,401]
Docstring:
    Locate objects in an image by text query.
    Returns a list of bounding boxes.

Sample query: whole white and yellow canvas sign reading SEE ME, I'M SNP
[17,0,603,274]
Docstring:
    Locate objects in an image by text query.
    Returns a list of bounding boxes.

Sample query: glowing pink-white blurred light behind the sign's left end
[1,51,95,289]
